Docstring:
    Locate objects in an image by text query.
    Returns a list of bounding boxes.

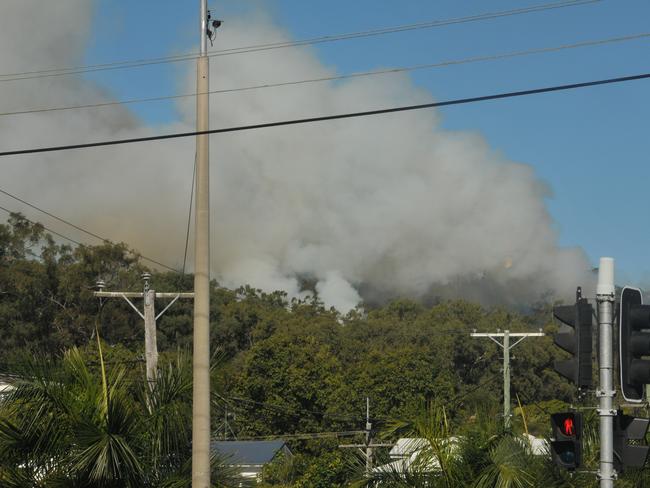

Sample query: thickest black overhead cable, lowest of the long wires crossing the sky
[0,73,650,156]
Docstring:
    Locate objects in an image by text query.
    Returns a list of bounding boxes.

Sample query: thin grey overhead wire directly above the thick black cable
[0,32,650,116]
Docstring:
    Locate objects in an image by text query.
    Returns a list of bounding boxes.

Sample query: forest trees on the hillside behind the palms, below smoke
[0,215,608,486]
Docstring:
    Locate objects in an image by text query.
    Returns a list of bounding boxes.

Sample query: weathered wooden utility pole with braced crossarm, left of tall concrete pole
[93,273,194,385]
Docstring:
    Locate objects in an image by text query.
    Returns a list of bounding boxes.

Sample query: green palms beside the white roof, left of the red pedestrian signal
[355,404,596,488]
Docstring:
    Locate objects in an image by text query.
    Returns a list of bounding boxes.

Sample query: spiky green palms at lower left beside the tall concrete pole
[0,340,237,488]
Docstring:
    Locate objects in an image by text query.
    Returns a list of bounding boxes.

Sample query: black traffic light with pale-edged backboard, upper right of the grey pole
[619,286,650,403]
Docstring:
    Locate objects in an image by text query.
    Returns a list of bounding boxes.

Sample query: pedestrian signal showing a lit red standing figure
[551,412,582,470]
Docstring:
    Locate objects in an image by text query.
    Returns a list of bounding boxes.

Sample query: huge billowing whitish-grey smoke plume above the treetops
[0,0,592,311]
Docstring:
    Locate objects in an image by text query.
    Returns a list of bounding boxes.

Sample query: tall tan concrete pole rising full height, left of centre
[192,0,210,488]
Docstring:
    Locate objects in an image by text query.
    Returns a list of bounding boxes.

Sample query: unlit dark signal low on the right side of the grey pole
[614,411,650,473]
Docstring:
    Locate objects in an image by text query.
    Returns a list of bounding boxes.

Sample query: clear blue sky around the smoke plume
[85,0,650,287]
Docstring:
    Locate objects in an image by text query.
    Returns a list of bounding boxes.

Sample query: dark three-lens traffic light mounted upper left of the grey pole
[553,287,593,388]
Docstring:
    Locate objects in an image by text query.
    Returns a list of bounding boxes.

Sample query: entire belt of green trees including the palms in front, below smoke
[0,215,643,487]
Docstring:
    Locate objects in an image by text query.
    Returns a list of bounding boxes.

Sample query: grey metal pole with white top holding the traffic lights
[596,258,616,488]
